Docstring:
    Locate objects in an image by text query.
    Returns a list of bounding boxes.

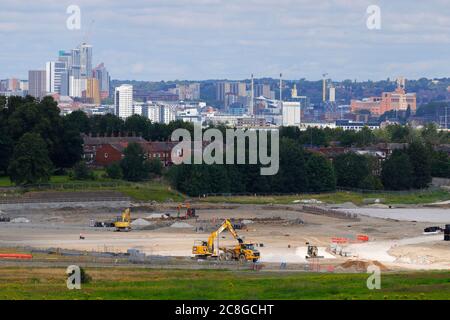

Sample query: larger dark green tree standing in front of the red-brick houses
[120,143,150,181]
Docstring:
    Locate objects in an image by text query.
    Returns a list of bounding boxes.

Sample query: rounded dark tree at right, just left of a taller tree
[381,150,414,190]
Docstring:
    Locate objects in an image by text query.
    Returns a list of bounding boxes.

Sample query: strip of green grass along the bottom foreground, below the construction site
[0,268,450,300]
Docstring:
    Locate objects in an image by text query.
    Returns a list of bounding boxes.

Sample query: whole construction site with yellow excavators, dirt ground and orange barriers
[0,191,450,273]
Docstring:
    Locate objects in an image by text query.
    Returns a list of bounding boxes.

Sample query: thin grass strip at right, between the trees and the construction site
[201,190,450,205]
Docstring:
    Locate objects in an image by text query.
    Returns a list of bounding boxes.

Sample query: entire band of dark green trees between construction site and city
[0,96,450,190]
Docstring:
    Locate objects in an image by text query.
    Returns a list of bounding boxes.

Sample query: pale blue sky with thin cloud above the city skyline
[0,0,450,81]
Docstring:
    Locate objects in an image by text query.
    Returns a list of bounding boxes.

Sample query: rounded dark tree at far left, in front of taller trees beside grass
[8,133,52,185]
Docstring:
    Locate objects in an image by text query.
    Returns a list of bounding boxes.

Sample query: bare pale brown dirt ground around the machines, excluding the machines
[0,203,450,269]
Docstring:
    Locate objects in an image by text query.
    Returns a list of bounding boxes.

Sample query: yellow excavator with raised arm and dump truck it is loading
[192,219,260,262]
